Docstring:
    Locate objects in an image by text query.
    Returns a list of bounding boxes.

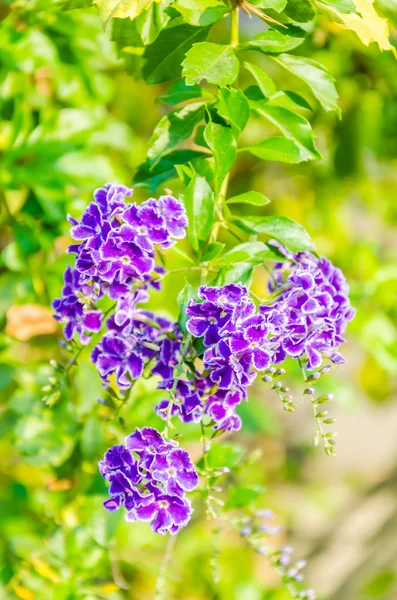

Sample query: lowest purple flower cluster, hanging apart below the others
[99,427,198,535]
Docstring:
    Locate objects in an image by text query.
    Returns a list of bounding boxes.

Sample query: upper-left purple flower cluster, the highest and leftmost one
[53,184,187,344]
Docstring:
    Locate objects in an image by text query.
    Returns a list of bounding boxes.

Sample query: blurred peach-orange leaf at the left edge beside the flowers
[6,304,57,342]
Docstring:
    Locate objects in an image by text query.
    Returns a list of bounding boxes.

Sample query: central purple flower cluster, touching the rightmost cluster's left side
[186,284,278,431]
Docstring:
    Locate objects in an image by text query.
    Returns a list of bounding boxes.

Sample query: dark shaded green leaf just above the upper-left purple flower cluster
[133,150,207,193]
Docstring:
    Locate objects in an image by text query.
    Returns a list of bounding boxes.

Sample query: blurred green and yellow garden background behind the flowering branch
[0,0,397,600]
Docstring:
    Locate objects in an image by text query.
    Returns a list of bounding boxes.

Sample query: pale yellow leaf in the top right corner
[338,0,397,56]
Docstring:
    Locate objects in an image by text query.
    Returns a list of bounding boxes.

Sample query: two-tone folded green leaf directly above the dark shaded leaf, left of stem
[147,102,205,163]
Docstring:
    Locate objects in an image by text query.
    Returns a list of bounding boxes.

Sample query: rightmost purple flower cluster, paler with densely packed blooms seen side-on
[260,246,355,370]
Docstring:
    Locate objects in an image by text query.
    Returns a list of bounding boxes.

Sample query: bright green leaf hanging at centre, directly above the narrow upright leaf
[204,121,237,193]
